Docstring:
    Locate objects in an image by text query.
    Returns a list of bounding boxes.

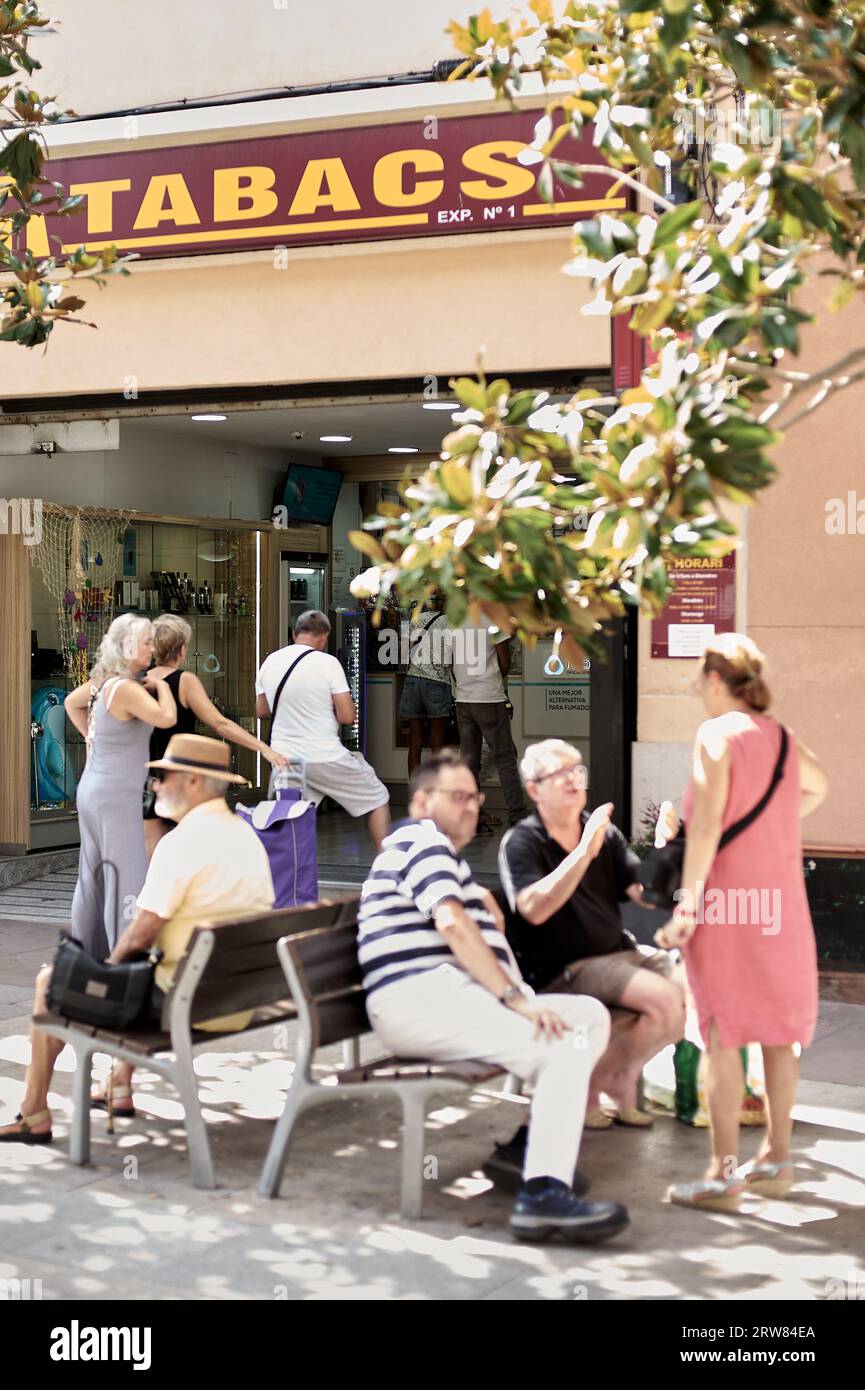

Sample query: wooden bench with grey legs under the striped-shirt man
[259,923,506,1220]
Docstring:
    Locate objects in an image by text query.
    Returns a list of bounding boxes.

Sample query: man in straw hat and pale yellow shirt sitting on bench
[0,734,274,1144]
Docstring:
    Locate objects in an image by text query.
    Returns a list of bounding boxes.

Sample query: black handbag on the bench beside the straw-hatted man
[47,931,163,1033]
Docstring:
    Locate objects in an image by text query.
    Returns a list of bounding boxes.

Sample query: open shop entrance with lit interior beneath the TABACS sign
[6,381,636,853]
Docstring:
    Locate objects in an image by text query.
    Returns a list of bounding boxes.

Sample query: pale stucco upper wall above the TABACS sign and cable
[32,0,489,115]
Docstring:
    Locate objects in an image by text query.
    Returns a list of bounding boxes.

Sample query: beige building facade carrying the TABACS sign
[0,0,865,978]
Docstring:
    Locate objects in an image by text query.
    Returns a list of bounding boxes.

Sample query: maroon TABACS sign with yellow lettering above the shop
[11,111,627,257]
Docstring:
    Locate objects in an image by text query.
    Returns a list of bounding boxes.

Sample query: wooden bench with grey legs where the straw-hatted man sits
[33,898,359,1188]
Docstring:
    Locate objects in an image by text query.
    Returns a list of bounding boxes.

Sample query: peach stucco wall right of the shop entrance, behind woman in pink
[634,279,865,851]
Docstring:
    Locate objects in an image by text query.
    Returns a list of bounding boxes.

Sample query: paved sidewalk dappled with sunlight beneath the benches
[0,922,865,1300]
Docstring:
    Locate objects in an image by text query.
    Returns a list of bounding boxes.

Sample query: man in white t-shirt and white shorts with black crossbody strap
[256,609,391,849]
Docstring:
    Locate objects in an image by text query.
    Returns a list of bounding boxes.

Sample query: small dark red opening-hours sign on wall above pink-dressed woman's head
[652,555,736,657]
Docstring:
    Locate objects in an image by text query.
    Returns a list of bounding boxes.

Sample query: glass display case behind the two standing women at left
[29,520,267,823]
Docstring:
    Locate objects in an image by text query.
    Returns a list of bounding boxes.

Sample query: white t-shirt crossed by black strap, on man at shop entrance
[256,642,349,763]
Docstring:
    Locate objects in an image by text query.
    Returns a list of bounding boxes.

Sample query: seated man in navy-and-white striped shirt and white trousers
[357,752,629,1241]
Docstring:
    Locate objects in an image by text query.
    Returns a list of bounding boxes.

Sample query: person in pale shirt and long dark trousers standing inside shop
[453,624,526,834]
